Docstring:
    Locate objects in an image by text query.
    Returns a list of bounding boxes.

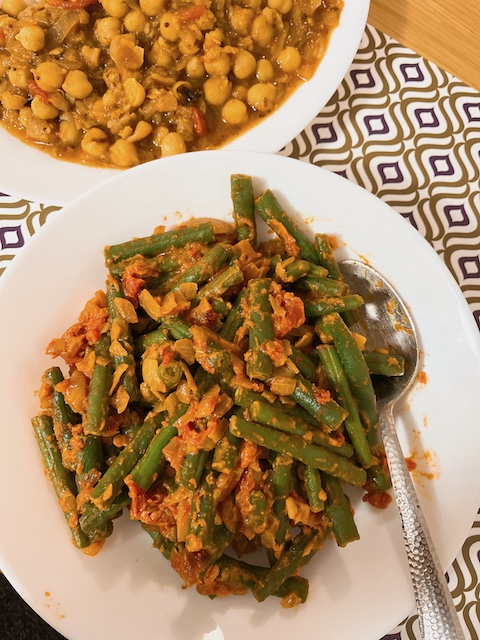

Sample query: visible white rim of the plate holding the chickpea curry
[0,0,370,205]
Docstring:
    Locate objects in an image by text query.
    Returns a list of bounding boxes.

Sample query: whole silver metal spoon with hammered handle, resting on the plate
[340,260,465,640]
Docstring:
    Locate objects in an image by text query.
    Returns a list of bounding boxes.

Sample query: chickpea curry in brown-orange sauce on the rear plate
[0,0,343,168]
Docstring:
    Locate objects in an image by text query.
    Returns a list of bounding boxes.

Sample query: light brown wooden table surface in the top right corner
[368,0,480,91]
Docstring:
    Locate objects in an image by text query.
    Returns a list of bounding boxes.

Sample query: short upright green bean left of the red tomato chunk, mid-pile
[242,278,274,380]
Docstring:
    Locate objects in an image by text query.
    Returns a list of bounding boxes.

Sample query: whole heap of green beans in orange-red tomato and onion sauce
[32,174,404,607]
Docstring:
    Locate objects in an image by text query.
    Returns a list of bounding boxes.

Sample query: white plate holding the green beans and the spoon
[0,151,480,640]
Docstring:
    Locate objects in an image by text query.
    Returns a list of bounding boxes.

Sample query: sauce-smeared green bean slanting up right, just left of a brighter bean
[91,413,165,509]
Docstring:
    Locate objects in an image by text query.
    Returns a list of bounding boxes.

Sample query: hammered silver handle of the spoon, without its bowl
[379,403,465,640]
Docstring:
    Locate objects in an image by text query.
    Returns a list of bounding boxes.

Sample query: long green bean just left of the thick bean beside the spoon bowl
[317,345,372,469]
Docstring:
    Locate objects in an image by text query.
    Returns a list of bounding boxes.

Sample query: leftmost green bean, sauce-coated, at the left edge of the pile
[32,415,90,549]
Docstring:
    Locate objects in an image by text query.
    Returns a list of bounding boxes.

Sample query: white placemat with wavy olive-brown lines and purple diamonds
[0,22,480,640]
